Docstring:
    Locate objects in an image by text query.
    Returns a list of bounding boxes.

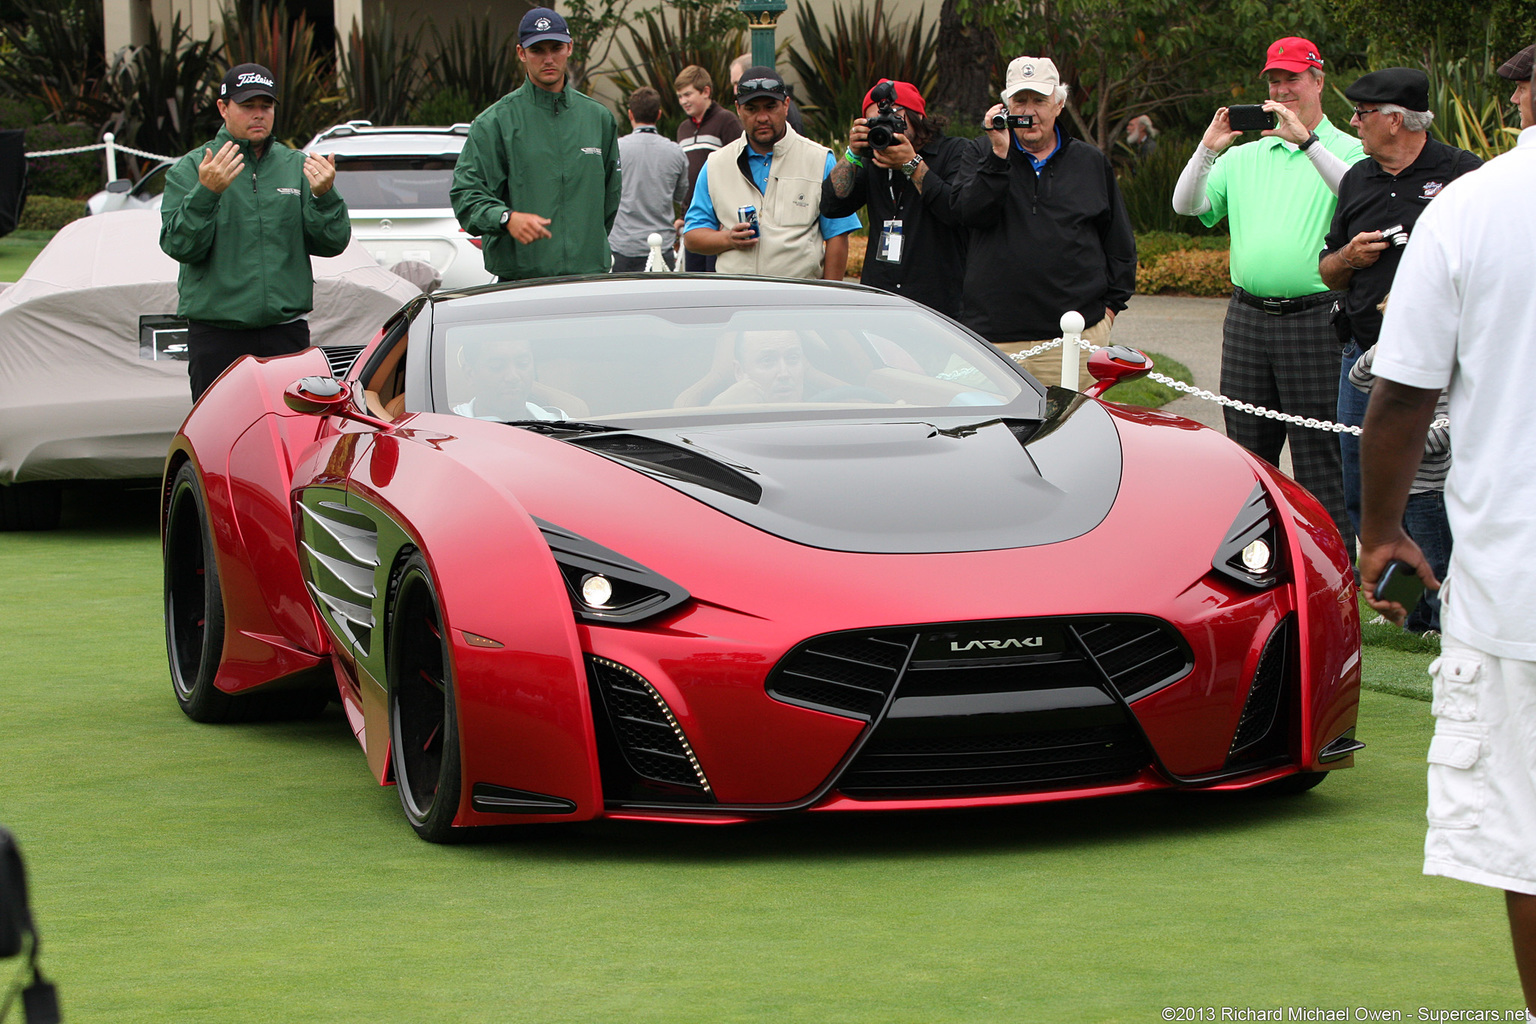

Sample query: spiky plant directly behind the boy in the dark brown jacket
[613,8,746,135]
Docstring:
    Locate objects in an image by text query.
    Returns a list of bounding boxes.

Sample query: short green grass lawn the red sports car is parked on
[0,493,1519,1024]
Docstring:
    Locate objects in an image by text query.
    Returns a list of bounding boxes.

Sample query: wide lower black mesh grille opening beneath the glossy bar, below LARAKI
[837,722,1152,800]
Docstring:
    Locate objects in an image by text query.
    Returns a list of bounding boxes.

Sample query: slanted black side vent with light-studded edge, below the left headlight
[587,654,710,792]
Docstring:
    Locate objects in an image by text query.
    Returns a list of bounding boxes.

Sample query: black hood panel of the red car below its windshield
[570,390,1121,554]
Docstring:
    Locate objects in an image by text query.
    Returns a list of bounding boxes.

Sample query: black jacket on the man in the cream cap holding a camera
[954,132,1137,342]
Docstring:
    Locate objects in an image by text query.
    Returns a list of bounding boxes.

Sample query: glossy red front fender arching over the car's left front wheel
[347,427,602,826]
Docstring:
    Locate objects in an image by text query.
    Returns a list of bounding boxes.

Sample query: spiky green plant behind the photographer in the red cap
[790,0,938,141]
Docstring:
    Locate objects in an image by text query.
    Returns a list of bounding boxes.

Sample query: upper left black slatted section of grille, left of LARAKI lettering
[768,631,914,720]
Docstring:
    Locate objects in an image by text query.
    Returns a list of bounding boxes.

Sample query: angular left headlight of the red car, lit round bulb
[533,519,688,625]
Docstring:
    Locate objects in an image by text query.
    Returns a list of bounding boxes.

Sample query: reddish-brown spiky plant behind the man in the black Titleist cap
[224,5,346,146]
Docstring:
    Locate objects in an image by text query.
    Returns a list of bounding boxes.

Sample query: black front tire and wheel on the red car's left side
[386,551,464,843]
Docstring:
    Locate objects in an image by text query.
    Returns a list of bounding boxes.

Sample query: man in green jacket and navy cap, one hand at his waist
[449,8,621,281]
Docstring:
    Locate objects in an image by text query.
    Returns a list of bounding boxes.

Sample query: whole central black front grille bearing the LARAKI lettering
[766,616,1193,800]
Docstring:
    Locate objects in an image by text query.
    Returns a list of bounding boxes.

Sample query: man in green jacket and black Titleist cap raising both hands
[160,64,352,401]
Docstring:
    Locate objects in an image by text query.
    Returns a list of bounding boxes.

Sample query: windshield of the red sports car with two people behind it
[433,306,1035,422]
